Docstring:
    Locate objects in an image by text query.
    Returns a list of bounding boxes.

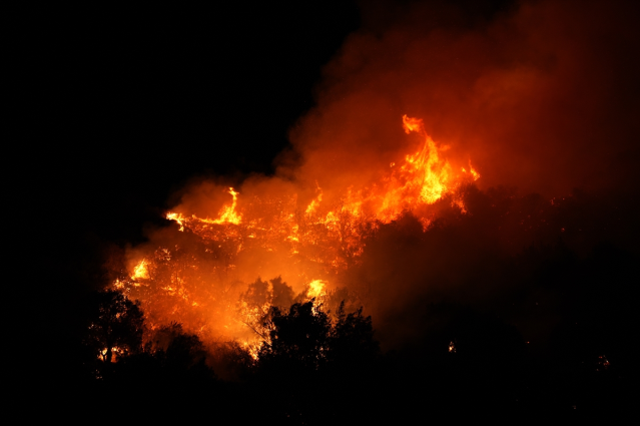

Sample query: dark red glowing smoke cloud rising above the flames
[280,1,640,196]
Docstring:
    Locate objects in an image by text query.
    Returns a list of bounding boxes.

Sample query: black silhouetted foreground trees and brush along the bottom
[37,240,637,424]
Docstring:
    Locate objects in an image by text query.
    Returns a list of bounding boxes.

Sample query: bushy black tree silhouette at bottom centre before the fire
[251,299,378,424]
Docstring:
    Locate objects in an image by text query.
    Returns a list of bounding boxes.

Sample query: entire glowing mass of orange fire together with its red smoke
[107,2,637,356]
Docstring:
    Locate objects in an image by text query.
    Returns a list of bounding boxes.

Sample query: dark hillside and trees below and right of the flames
[28,183,640,425]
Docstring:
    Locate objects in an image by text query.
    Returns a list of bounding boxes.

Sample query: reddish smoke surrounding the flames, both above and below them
[117,1,640,347]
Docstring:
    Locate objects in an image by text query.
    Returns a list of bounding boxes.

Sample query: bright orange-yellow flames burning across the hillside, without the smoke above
[113,115,480,348]
